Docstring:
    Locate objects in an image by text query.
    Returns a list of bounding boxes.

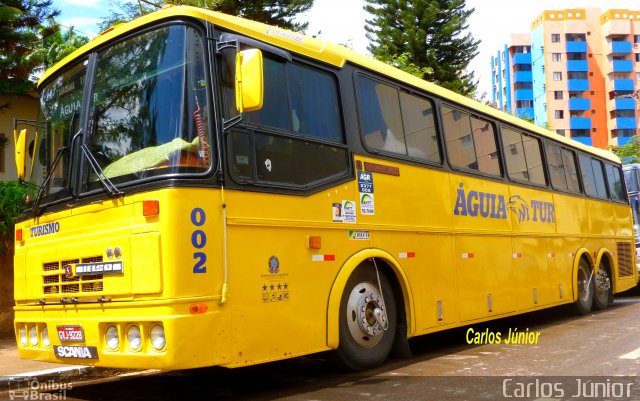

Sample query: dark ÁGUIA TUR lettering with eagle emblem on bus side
[453,184,555,223]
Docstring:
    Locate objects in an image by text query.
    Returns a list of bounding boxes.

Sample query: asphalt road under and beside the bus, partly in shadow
[6,290,640,401]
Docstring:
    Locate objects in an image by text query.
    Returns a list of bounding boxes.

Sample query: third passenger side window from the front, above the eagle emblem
[501,127,547,185]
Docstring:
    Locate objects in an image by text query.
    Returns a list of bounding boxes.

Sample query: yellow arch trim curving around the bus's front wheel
[327,249,415,349]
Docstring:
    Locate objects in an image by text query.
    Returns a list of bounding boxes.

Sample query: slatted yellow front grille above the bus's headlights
[42,256,103,295]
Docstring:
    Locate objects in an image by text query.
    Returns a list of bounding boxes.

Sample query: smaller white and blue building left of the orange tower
[491,33,533,119]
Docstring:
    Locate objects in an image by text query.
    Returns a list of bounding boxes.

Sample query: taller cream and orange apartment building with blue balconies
[492,8,640,148]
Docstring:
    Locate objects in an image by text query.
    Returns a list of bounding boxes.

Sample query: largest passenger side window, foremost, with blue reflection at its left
[357,76,441,162]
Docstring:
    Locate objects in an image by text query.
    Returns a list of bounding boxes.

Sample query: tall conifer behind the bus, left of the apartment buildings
[364,0,480,96]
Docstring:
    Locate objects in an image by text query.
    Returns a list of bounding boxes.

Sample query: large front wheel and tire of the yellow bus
[335,264,397,371]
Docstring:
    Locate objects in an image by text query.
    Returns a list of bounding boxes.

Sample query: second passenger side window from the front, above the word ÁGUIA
[441,105,500,176]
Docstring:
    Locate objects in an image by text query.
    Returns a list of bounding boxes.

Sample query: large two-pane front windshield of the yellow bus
[35,24,212,203]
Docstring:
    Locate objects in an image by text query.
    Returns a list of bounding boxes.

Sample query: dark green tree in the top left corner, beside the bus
[0,0,59,96]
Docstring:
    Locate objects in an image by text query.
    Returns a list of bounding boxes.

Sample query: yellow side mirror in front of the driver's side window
[235,49,264,113]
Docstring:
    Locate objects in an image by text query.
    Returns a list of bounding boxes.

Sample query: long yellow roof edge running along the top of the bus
[38,6,620,163]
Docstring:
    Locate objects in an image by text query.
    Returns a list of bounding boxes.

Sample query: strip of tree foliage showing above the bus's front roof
[100,0,313,32]
